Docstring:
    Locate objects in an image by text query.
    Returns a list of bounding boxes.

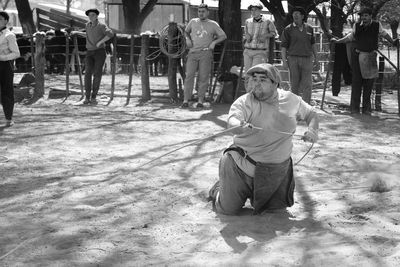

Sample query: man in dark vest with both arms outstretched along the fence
[331,7,398,115]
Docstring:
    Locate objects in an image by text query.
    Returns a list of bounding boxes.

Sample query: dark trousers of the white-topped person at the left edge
[0,61,14,120]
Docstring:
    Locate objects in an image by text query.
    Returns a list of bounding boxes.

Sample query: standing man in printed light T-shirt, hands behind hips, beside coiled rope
[182,4,226,108]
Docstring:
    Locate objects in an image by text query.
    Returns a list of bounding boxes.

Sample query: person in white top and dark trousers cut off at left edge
[0,11,20,127]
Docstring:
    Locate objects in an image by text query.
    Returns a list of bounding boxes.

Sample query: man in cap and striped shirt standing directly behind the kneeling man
[243,2,276,77]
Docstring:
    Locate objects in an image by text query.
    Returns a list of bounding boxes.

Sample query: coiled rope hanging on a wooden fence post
[160,24,187,58]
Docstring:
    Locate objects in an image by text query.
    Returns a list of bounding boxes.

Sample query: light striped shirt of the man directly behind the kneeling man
[244,15,276,49]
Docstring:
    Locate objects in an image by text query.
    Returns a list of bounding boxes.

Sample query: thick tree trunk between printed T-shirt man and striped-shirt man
[218,0,243,73]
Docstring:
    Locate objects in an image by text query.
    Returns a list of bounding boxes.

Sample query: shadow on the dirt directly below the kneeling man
[217,208,312,253]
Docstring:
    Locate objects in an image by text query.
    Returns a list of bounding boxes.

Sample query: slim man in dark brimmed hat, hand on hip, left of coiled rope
[83,8,114,104]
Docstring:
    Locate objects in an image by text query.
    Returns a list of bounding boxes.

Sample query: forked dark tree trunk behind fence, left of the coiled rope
[122,0,157,34]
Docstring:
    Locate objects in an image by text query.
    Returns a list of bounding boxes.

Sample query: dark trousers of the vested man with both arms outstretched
[350,50,375,112]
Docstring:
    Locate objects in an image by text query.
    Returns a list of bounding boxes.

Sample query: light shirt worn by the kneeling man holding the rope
[228,89,313,177]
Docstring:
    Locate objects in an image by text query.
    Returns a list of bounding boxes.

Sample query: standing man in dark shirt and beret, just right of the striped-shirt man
[281,7,318,104]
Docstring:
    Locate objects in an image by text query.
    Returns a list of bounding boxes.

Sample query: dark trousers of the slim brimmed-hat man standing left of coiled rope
[85,48,106,99]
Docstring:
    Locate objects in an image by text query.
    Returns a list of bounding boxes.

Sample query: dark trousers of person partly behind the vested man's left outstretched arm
[332,44,352,96]
